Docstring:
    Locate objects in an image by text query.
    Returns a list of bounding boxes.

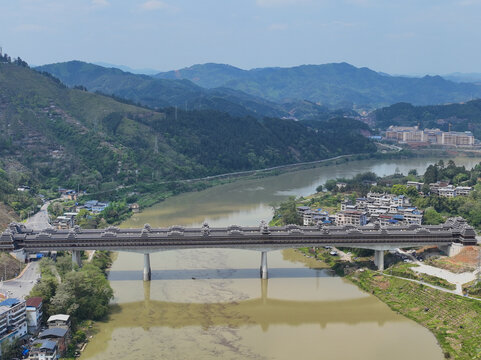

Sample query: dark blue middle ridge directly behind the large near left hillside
[36,61,328,118]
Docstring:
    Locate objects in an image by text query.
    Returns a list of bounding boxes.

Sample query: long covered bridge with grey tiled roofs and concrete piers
[0,218,476,280]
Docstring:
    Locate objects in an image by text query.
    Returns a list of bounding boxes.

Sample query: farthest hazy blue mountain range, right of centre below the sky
[155,63,481,108]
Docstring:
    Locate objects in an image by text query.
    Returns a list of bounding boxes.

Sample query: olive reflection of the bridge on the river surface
[112,279,402,331]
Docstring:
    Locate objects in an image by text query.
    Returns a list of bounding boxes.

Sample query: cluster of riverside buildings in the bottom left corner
[0,297,71,360]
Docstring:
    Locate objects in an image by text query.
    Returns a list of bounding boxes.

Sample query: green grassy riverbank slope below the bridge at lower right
[348,270,481,360]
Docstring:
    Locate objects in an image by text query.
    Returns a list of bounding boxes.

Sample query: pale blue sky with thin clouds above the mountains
[0,0,481,75]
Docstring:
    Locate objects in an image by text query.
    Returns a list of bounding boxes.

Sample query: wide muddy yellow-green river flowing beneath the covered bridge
[81,158,479,360]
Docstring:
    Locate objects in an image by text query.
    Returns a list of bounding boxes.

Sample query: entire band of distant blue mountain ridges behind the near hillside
[37,61,481,112]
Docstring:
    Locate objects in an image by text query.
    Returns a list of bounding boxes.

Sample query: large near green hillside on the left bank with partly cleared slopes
[0,64,375,197]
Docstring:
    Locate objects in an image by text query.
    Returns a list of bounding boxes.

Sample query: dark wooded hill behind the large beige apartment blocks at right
[372,100,481,139]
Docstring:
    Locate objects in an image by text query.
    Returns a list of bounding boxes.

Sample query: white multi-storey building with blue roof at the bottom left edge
[0,298,27,348]
